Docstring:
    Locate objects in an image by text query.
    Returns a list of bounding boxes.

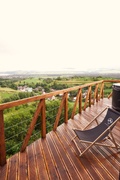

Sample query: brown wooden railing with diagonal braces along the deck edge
[0,80,120,166]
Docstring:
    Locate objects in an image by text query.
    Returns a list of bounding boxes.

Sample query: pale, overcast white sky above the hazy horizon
[0,0,120,72]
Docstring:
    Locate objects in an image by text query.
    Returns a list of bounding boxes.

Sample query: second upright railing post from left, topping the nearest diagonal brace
[41,99,46,138]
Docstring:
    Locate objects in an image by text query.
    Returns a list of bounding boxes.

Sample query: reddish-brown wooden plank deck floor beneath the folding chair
[0,98,120,180]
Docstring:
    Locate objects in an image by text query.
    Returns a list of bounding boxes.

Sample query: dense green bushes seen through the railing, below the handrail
[4,99,72,156]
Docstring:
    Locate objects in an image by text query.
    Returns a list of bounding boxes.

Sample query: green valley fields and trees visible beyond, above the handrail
[0,76,112,103]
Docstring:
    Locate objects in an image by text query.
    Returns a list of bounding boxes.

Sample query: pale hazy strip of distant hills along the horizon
[0,68,120,78]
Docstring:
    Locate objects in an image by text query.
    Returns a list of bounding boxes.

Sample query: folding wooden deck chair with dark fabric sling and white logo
[72,107,120,156]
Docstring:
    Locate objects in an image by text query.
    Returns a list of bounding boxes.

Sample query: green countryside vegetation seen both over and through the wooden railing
[0,76,115,157]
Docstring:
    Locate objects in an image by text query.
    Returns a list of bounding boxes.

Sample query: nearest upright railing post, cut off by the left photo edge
[0,110,6,166]
